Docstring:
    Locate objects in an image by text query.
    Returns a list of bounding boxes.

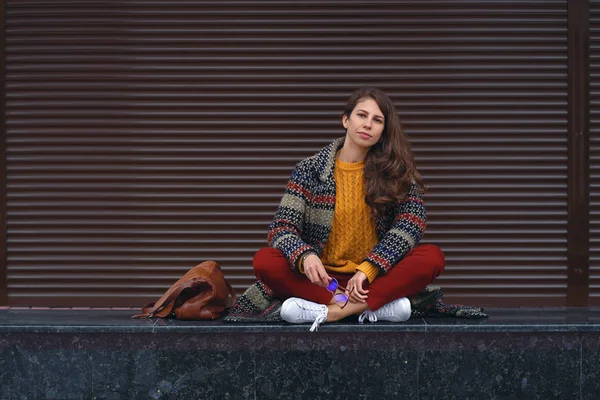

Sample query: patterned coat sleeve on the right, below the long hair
[364,183,427,274]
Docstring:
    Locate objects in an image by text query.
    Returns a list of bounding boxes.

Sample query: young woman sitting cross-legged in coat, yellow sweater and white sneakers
[253,88,445,331]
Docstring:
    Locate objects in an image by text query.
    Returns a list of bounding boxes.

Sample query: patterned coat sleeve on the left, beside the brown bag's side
[267,159,315,270]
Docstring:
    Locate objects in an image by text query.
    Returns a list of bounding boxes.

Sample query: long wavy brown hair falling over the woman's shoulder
[343,87,425,217]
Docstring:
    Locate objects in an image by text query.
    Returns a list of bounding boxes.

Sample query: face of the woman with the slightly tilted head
[342,98,385,149]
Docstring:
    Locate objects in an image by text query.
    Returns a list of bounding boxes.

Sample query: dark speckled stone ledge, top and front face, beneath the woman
[0,309,600,400]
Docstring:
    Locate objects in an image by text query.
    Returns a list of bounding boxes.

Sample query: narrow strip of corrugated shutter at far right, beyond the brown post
[589,1,600,306]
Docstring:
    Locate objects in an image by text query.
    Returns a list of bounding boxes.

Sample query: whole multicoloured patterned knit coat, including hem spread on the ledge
[223,138,487,323]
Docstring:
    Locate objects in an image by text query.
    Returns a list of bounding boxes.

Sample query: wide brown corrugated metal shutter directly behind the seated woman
[6,0,567,305]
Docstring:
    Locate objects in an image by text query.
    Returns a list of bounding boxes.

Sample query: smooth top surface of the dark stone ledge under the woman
[0,308,600,333]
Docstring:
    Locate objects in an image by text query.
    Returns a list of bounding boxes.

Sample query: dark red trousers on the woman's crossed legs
[253,244,445,311]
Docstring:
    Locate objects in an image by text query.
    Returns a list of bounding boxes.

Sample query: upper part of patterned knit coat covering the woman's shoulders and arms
[268,138,427,274]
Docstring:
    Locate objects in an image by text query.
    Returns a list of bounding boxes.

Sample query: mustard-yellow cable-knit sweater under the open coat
[321,159,379,282]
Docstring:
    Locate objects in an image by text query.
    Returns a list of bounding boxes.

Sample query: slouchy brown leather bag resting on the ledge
[131,261,236,320]
